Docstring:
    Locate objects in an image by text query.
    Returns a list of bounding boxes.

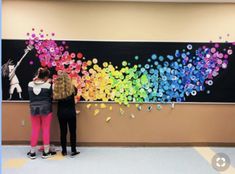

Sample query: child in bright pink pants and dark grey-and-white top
[27,68,56,159]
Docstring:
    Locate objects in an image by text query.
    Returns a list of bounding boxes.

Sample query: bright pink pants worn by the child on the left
[31,113,52,147]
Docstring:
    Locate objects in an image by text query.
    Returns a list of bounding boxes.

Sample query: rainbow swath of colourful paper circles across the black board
[3,29,235,106]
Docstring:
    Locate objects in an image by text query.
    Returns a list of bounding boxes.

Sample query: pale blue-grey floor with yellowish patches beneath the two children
[2,146,235,174]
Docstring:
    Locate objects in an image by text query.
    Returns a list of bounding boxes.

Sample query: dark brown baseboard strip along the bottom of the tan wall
[2,141,235,147]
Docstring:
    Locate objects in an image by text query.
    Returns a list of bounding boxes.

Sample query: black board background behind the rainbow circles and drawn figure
[2,39,235,102]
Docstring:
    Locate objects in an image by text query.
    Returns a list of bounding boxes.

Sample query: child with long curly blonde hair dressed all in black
[53,71,80,157]
